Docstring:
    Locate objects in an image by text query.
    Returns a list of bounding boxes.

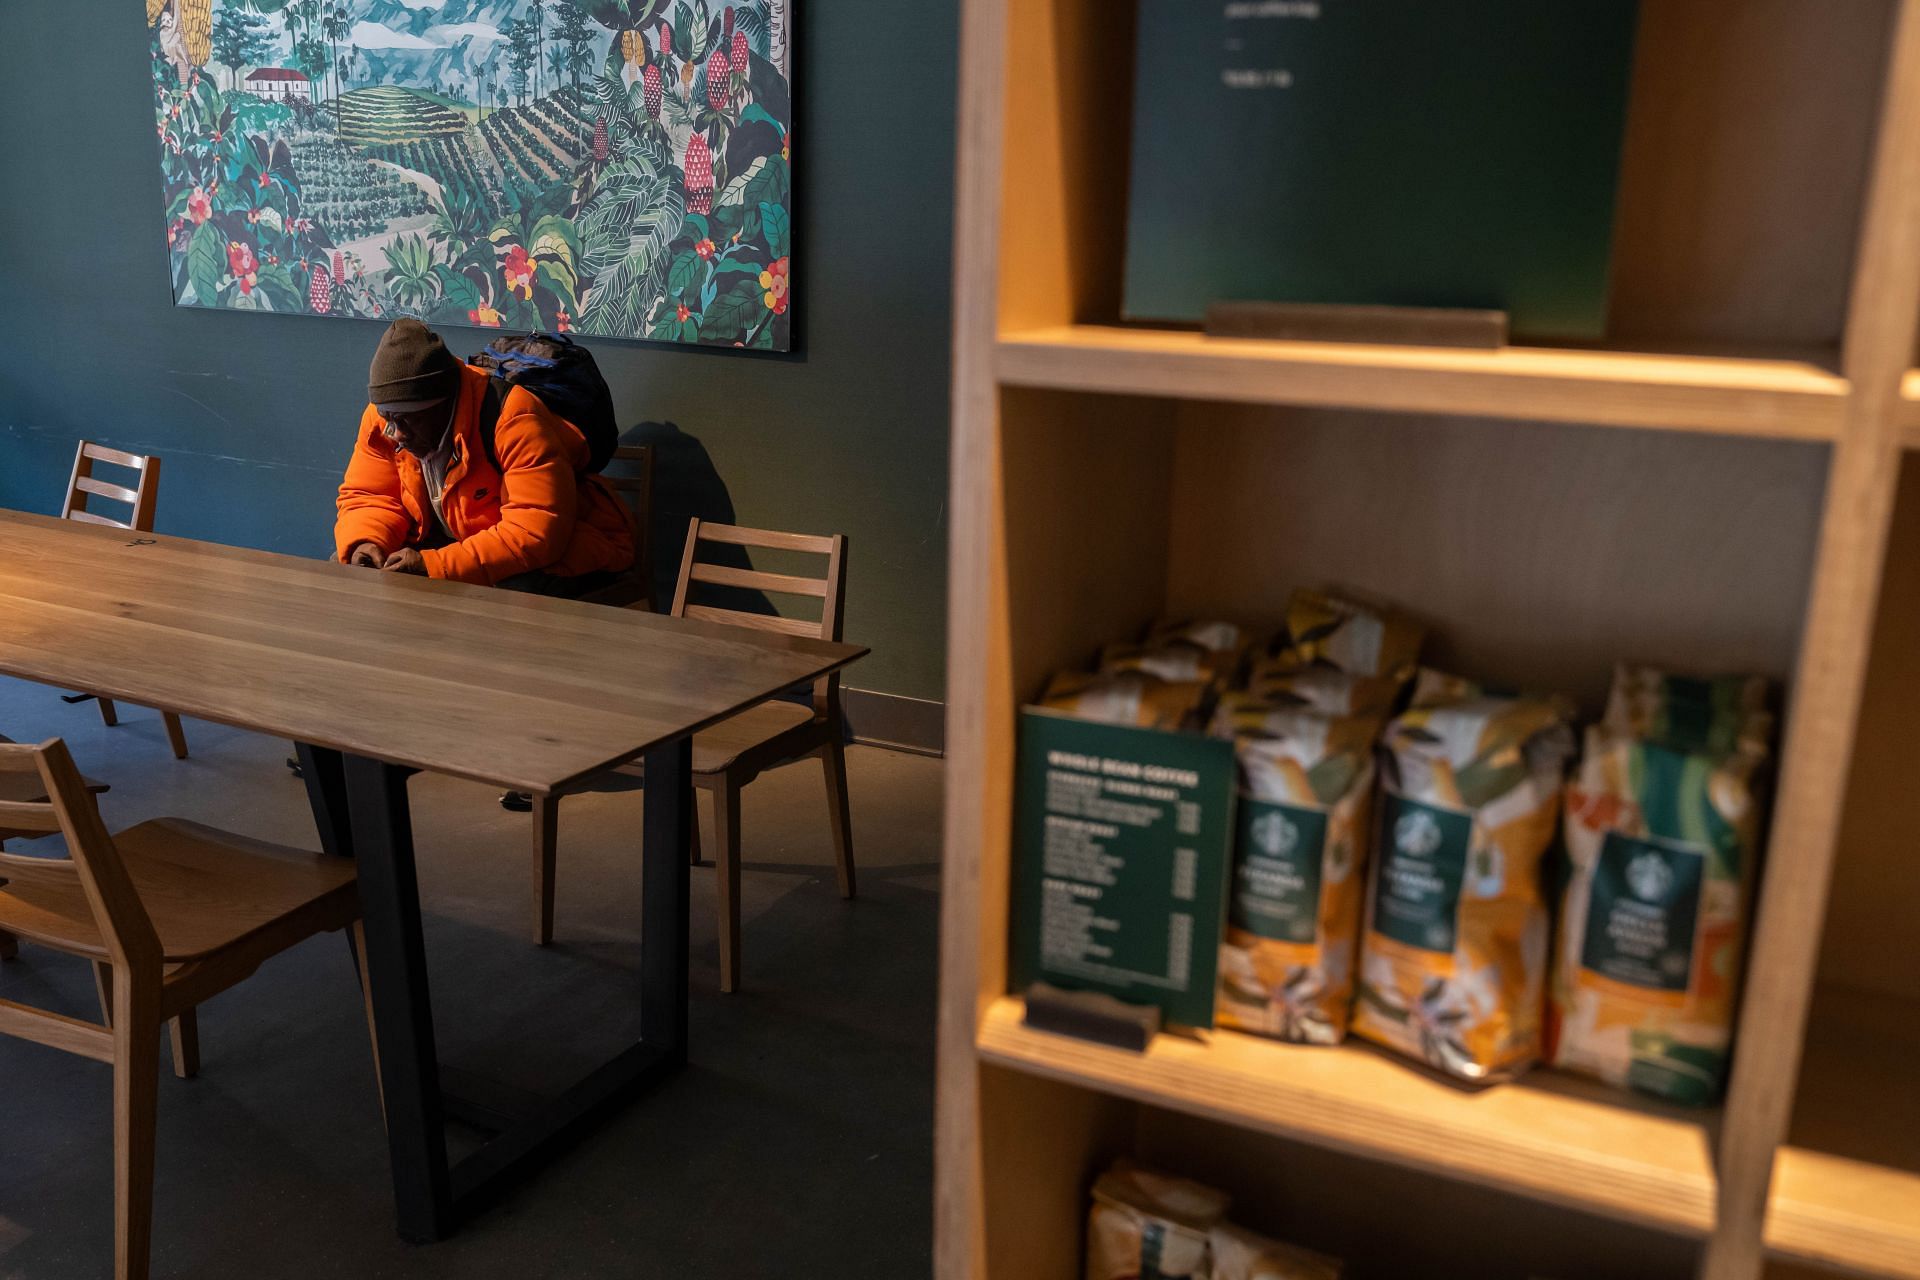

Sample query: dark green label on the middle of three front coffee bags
[1373,793,1473,952]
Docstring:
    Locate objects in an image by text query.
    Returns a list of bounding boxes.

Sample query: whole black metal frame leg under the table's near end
[298,739,693,1244]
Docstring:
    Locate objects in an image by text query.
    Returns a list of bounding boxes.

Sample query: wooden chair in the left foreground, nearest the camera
[0,739,378,1280]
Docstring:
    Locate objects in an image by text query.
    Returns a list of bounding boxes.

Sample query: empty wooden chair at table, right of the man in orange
[534,518,854,992]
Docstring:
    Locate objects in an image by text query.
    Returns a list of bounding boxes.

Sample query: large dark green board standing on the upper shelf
[1125,0,1638,340]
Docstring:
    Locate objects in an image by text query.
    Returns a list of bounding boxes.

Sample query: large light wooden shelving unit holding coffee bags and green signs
[937,0,1920,1280]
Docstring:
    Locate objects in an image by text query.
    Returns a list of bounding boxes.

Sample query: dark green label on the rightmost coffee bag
[1580,831,1707,992]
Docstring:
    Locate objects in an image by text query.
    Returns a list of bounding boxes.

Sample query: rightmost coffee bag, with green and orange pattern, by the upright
[1548,666,1772,1103]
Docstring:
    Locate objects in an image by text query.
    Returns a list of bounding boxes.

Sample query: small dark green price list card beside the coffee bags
[1012,710,1235,1027]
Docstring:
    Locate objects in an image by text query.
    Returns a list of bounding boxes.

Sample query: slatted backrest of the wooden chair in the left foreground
[0,737,161,971]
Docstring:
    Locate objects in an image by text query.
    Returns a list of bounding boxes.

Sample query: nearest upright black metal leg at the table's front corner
[346,756,453,1244]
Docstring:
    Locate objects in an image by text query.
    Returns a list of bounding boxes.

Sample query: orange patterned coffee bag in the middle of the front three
[1354,672,1572,1080]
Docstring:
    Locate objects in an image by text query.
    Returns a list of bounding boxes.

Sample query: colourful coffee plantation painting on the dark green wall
[144,0,793,351]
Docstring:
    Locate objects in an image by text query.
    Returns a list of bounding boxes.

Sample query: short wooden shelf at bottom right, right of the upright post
[1766,986,1920,1280]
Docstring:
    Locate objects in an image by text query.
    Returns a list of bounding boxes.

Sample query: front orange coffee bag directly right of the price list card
[1213,695,1380,1044]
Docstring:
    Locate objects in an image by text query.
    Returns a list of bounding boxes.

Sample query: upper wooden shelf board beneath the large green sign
[995,324,1847,439]
